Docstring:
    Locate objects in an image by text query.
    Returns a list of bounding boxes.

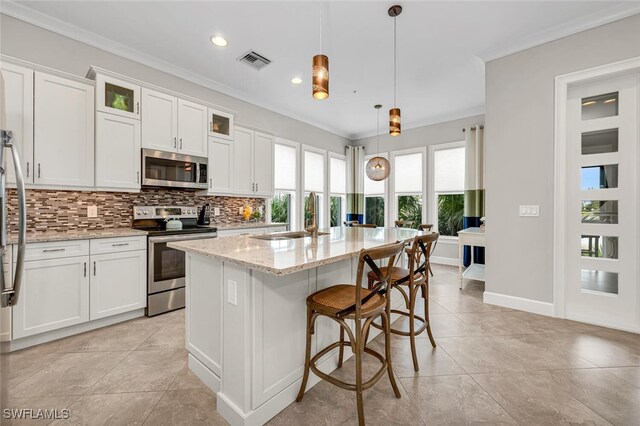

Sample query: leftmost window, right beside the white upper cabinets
[271,143,298,227]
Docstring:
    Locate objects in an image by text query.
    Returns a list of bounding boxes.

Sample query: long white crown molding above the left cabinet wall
[0,0,349,139]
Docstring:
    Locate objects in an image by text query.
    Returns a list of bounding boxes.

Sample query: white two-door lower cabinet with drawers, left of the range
[12,237,147,339]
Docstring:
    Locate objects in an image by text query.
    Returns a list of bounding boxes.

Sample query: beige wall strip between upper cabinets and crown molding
[0,14,349,154]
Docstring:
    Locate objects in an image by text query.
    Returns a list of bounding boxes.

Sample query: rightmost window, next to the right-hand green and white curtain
[433,144,465,237]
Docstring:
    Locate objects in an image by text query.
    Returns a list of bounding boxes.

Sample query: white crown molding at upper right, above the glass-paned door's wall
[477,1,640,63]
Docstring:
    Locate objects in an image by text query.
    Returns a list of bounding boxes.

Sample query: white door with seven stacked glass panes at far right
[564,75,640,330]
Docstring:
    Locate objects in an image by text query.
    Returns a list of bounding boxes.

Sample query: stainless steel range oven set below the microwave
[133,206,218,316]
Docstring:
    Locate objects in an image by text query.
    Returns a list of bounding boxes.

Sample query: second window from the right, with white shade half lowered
[392,151,424,229]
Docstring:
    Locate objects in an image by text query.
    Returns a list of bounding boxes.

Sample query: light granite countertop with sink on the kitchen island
[169,227,418,276]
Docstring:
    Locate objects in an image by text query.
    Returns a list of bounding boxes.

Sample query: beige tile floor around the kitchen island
[2,266,640,425]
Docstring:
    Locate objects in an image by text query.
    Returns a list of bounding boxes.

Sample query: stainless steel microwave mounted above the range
[142,149,208,189]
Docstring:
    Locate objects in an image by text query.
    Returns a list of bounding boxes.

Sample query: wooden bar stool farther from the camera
[367,233,440,371]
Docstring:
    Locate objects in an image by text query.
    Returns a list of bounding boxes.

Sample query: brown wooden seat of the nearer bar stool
[307,284,385,318]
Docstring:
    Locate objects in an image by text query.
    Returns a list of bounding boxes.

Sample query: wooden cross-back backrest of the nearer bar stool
[336,241,404,319]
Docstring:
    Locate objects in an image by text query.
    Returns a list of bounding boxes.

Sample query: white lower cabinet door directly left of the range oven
[89,250,147,321]
